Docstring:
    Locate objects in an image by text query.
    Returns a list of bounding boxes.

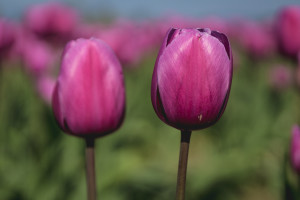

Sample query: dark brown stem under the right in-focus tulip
[176,131,192,200]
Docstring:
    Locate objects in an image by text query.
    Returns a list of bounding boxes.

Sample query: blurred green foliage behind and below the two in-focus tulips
[0,52,300,200]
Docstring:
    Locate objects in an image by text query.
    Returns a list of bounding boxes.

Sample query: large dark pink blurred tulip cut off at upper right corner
[276,6,300,56]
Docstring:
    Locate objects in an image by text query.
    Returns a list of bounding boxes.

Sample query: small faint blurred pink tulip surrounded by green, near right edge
[270,65,292,90]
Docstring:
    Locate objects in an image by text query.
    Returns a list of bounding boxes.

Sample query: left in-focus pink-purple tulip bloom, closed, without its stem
[52,38,125,137]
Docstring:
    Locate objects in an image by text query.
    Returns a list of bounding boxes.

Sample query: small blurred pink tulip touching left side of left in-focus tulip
[36,76,55,104]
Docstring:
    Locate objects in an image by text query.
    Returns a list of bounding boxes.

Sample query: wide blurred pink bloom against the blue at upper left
[25,2,79,40]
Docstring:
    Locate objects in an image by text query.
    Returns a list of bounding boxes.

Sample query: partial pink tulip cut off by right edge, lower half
[290,125,300,174]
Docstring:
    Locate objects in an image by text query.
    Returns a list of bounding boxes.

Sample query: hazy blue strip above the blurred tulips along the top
[0,0,300,19]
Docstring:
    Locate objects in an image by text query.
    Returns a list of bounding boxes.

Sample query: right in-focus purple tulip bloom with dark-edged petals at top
[151,28,233,130]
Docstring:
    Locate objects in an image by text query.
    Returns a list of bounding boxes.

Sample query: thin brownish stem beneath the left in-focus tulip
[85,138,96,200]
